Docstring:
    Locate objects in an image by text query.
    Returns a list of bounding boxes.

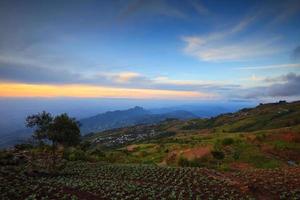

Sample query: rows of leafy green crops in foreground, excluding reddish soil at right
[0,162,260,200]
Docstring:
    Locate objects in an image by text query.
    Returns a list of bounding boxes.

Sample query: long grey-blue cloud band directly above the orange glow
[0,52,239,99]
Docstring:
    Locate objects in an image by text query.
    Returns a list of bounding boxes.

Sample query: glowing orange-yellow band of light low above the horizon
[0,83,214,99]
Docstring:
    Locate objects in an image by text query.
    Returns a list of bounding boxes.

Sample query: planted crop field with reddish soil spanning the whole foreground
[0,162,300,199]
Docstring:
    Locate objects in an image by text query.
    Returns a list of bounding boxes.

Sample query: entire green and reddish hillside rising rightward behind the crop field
[86,102,300,169]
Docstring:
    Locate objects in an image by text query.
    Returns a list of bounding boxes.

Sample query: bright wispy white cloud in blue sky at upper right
[182,15,280,62]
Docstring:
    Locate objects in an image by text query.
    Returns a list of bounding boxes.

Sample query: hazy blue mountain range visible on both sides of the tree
[0,106,198,148]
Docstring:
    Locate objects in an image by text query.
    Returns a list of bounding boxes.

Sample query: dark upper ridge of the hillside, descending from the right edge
[183,101,300,132]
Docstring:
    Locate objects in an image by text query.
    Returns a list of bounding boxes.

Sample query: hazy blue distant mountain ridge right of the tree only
[80,106,197,134]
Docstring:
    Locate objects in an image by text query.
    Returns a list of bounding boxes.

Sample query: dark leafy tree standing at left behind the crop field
[26,111,80,169]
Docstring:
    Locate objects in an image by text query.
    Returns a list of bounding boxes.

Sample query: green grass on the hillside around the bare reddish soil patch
[92,126,299,170]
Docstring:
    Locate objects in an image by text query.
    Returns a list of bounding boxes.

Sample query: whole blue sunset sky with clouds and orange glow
[0,0,300,102]
